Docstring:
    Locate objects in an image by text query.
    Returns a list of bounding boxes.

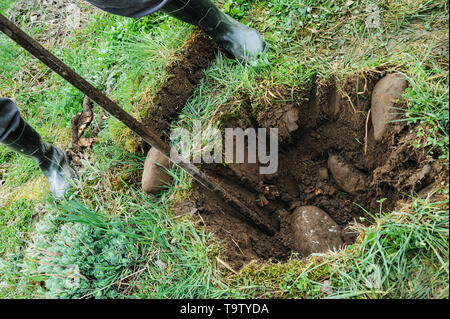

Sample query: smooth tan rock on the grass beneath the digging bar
[142,147,172,194]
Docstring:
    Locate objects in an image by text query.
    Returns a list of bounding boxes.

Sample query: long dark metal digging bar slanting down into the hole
[0,14,275,235]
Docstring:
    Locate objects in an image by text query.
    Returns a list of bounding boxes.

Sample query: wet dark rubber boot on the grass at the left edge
[2,118,76,197]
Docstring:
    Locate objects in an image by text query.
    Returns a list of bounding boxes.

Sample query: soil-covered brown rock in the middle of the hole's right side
[328,155,367,195]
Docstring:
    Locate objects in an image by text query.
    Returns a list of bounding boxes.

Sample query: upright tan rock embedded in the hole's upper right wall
[371,73,408,141]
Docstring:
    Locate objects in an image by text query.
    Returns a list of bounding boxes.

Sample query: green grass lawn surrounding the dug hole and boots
[0,0,449,298]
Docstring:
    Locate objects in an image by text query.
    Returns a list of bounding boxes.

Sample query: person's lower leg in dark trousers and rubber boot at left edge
[0,98,76,197]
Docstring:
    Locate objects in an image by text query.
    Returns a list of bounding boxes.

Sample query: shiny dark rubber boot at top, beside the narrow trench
[161,0,265,62]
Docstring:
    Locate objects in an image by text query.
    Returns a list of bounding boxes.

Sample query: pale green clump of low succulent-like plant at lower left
[22,208,138,298]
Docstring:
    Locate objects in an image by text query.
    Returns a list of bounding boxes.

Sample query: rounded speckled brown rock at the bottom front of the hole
[291,206,343,255]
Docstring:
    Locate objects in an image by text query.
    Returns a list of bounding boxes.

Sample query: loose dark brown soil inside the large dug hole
[175,72,442,268]
